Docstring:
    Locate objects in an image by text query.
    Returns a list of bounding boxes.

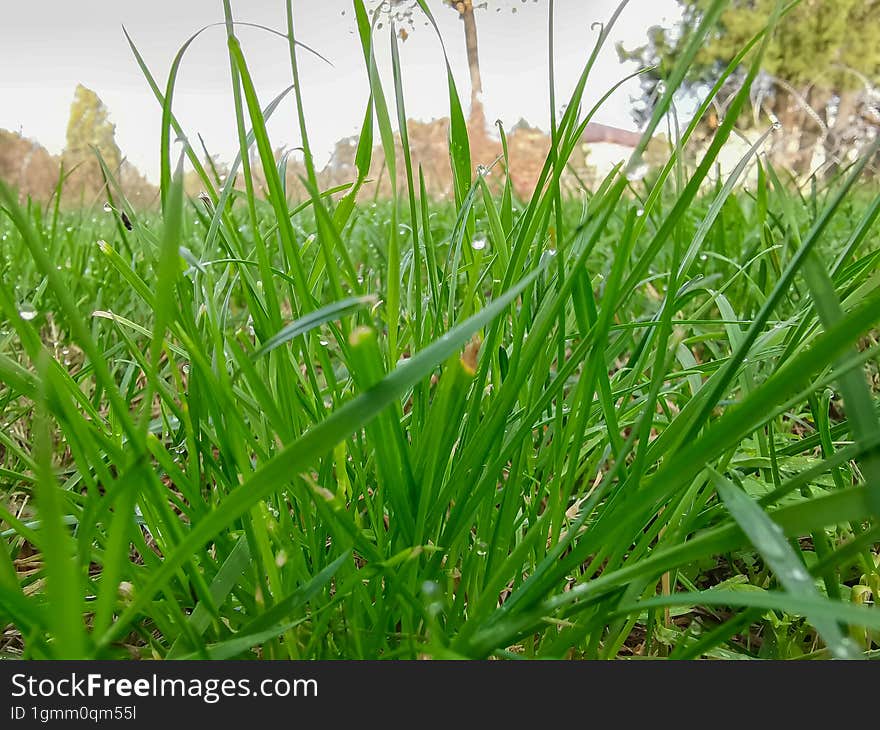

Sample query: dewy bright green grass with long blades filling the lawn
[0,0,880,659]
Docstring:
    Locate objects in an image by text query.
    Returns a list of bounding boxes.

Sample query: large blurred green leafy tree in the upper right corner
[618,0,880,174]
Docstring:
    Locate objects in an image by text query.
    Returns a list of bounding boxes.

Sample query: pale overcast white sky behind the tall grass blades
[0,0,678,180]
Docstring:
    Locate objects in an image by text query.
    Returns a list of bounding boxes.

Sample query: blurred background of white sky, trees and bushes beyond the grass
[0,0,880,206]
